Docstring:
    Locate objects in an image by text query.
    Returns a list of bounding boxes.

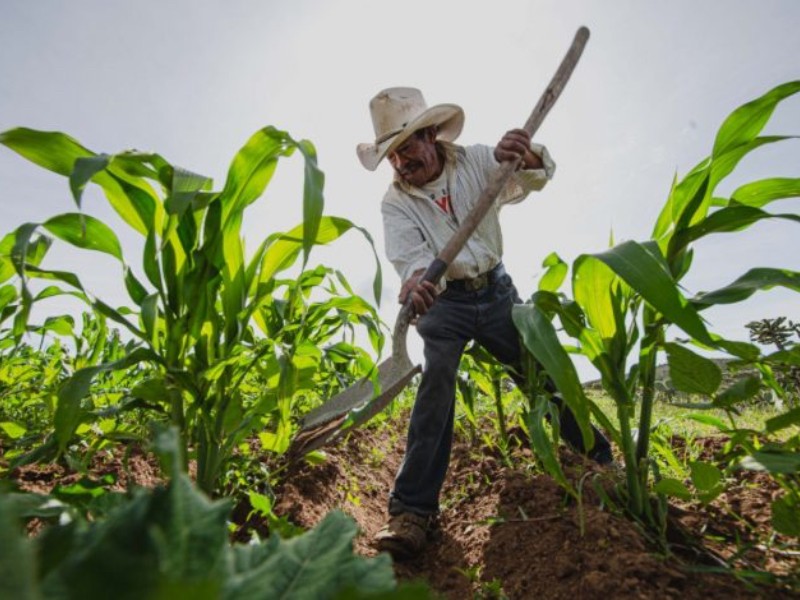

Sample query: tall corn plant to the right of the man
[513,81,800,523]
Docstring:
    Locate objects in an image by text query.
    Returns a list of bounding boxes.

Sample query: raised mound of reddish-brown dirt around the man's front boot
[277,419,797,600]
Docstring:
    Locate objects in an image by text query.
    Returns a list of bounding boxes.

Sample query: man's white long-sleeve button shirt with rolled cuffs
[381,142,556,281]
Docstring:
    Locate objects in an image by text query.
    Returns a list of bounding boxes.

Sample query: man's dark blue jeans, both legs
[389,272,610,515]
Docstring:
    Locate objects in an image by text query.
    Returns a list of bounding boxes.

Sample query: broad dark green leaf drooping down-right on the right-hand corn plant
[592,241,714,346]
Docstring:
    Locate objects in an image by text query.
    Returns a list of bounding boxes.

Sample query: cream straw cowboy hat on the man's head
[356,87,464,171]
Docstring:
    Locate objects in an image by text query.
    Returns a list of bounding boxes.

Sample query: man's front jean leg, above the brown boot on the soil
[389,298,471,515]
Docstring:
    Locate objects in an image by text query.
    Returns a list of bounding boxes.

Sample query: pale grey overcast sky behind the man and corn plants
[0,0,800,374]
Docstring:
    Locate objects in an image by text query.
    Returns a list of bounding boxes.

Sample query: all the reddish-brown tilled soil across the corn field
[11,417,800,600]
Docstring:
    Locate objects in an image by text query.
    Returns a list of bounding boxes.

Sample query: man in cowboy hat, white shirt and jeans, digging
[357,87,612,559]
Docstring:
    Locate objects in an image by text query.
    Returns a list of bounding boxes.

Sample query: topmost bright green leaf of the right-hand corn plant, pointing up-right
[713,81,800,157]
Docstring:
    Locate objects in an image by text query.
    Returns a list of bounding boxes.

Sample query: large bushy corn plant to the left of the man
[0,127,380,492]
